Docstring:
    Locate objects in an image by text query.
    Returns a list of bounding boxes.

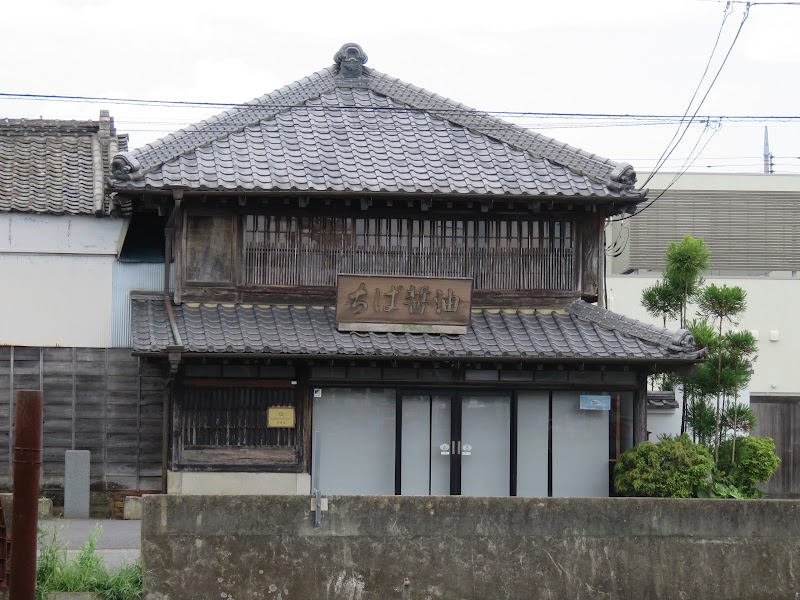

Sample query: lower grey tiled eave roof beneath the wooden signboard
[131,297,705,361]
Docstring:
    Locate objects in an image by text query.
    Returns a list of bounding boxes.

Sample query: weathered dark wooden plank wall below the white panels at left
[0,346,166,490]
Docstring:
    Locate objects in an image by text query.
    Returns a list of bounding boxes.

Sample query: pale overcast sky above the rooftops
[0,0,800,178]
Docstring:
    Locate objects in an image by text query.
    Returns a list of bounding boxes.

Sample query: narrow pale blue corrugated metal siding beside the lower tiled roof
[111,262,172,348]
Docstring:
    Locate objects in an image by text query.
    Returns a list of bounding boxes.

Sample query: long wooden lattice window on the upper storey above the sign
[244,215,574,290]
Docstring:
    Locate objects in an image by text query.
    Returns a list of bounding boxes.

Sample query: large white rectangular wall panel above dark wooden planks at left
[0,253,115,348]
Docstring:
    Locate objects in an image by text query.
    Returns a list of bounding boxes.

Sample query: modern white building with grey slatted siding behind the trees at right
[607,173,800,494]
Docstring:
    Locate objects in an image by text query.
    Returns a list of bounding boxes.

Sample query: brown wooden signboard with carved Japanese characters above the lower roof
[336,274,472,334]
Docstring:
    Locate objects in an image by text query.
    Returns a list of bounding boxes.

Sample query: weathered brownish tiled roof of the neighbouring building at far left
[0,111,127,215]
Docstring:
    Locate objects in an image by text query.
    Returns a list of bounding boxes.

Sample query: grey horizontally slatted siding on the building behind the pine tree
[629,190,800,271]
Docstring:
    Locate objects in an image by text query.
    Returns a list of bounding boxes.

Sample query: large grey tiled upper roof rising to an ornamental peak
[111,45,641,200]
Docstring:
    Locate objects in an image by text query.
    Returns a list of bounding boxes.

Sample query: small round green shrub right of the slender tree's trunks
[717,436,781,498]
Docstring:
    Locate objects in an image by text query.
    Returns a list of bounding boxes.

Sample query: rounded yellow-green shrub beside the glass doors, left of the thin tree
[614,434,714,498]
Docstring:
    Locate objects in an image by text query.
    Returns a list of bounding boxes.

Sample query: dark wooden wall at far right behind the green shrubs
[750,395,800,498]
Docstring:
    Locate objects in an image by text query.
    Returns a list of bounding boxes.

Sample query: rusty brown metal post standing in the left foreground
[10,391,42,600]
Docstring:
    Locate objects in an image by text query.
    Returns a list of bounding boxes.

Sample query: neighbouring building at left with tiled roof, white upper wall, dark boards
[0,111,164,490]
